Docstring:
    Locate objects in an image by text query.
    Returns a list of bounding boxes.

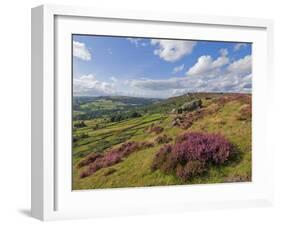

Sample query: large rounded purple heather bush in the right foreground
[151,132,233,180]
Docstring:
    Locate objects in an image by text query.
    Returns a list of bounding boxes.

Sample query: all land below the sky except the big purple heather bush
[72,93,249,190]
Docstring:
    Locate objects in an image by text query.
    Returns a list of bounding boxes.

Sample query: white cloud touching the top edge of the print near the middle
[151,39,196,62]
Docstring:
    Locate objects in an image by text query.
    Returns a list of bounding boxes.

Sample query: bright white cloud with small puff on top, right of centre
[187,49,229,75]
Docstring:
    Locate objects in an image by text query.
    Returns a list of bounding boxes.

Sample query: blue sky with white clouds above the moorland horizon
[72,35,252,98]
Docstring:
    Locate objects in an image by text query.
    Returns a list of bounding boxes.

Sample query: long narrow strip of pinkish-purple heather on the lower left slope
[78,141,153,178]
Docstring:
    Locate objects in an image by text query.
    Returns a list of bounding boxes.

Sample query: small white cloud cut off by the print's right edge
[227,55,252,74]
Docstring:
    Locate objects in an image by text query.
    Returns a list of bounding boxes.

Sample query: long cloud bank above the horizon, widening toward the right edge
[129,50,252,97]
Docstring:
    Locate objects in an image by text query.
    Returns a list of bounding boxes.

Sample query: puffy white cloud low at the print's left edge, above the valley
[73,74,114,96]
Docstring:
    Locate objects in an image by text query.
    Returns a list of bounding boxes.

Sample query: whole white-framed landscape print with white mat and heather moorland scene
[32,5,273,220]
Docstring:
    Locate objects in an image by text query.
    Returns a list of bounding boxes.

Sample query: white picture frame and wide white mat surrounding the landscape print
[31,5,273,220]
